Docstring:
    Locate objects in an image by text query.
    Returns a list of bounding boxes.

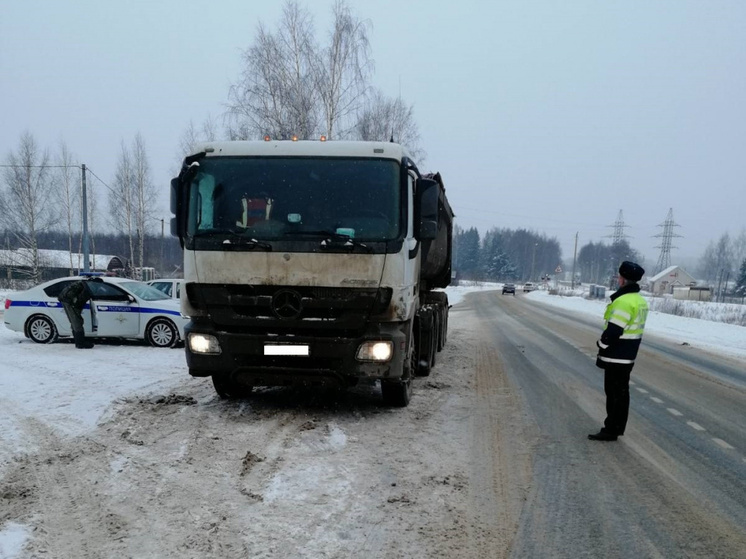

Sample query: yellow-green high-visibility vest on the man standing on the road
[598,293,648,365]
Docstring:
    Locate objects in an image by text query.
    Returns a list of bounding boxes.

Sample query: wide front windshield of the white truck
[187,157,401,241]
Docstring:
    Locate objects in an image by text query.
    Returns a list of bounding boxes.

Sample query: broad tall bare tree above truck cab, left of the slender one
[228,0,318,139]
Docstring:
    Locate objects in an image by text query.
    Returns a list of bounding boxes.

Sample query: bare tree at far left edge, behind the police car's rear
[0,132,57,283]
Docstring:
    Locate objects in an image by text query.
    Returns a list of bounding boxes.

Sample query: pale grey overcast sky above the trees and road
[0,0,746,267]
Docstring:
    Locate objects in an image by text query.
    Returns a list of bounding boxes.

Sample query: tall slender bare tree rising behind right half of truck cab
[315,0,373,138]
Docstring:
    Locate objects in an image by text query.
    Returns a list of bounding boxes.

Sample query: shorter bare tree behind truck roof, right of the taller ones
[354,91,426,161]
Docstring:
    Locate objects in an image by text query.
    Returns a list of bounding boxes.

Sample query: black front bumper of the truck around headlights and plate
[185,323,410,386]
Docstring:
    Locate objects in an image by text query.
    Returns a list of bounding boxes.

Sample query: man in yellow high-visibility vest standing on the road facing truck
[588,260,648,441]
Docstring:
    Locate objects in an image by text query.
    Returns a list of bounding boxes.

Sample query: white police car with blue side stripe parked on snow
[3,276,189,347]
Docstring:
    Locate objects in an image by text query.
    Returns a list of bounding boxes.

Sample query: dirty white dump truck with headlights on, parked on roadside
[171,138,453,407]
